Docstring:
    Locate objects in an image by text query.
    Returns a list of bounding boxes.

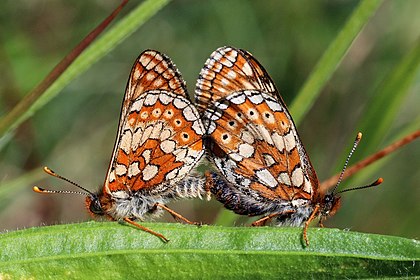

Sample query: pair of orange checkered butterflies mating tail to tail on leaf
[34,47,381,244]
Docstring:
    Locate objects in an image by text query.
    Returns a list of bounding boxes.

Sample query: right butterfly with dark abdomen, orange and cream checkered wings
[195,47,382,245]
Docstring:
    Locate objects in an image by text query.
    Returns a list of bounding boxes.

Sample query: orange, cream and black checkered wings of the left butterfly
[104,50,204,193]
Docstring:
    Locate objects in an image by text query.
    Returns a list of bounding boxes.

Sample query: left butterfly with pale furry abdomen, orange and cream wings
[34,50,204,241]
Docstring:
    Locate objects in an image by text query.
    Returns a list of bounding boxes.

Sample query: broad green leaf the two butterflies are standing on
[0,222,420,279]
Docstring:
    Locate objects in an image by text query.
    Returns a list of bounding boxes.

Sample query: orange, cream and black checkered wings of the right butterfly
[196,47,318,208]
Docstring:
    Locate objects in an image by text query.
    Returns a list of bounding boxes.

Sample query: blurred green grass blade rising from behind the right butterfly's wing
[290,0,383,124]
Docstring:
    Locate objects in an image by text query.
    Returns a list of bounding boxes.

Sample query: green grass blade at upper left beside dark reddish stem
[0,0,169,136]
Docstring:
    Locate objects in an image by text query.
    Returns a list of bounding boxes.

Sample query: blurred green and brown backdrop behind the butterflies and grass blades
[0,0,420,241]
